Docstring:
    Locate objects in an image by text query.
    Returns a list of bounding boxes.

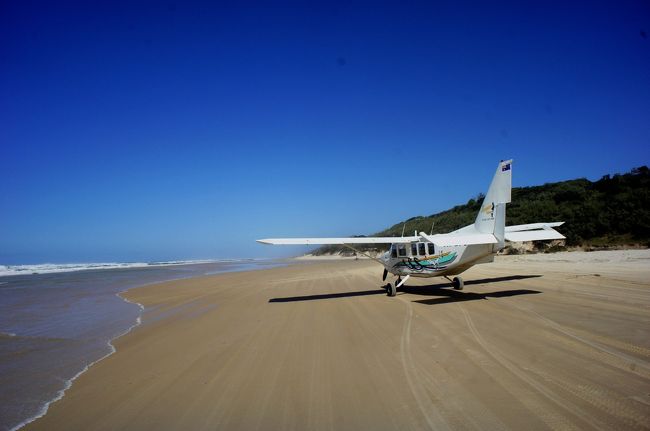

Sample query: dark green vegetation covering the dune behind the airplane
[314,166,650,254]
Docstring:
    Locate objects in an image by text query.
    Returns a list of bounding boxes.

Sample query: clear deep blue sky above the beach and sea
[0,1,650,263]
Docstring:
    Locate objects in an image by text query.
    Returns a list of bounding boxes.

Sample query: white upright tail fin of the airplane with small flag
[474,160,512,248]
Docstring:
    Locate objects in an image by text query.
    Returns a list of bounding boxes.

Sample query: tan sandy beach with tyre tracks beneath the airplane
[24,250,650,430]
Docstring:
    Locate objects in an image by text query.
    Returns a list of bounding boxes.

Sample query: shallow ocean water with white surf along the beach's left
[0,260,283,431]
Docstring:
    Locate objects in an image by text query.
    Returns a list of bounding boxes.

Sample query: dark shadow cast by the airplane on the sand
[269,275,542,305]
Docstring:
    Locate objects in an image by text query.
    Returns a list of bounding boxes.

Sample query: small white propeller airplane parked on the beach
[257,160,564,296]
